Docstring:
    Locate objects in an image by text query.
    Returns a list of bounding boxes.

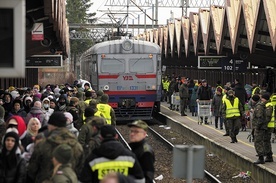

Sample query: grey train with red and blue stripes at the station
[81,39,162,121]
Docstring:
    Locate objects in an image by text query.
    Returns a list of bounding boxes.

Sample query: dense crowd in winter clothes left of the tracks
[0,83,155,183]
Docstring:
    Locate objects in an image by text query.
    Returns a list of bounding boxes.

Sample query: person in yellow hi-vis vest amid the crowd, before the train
[97,94,116,125]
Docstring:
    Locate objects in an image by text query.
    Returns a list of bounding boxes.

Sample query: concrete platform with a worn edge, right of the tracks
[158,102,276,183]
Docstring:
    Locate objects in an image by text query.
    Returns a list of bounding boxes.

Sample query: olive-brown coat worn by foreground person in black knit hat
[28,128,83,183]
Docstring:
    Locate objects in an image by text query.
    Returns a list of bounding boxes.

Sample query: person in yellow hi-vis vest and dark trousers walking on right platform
[222,90,244,143]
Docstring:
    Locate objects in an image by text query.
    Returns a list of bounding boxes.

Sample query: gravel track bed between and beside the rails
[117,125,255,183]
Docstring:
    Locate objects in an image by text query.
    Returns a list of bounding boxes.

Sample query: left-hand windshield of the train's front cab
[101,58,125,73]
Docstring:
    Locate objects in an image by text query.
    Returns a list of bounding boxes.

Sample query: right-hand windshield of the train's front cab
[129,58,154,73]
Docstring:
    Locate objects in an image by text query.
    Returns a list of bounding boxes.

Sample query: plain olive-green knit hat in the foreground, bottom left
[53,144,73,164]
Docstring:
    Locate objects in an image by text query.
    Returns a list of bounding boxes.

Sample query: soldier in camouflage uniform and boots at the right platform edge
[252,93,273,164]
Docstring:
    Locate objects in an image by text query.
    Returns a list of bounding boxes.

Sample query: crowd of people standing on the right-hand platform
[162,74,276,164]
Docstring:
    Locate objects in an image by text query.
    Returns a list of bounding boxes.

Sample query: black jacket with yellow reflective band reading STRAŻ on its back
[79,139,145,183]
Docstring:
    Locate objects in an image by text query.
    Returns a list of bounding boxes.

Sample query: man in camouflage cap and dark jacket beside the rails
[128,120,155,183]
